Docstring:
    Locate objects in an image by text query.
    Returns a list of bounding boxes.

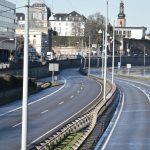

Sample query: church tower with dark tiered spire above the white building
[117,0,126,27]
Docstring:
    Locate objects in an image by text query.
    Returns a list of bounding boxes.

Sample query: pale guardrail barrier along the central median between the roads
[32,76,116,150]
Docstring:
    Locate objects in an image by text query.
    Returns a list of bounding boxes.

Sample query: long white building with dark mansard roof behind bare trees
[50,11,86,36]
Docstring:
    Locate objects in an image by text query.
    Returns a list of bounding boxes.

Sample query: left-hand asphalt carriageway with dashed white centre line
[0,69,101,150]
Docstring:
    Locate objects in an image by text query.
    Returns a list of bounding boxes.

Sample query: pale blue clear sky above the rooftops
[8,0,150,33]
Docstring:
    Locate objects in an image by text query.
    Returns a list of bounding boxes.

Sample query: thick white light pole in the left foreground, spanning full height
[21,0,29,150]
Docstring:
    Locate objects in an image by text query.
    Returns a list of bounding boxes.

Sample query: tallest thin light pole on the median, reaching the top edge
[103,1,108,101]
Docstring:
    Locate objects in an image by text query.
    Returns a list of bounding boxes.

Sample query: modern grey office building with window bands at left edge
[0,0,16,62]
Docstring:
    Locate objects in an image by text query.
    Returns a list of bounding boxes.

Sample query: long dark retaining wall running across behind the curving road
[0,56,150,78]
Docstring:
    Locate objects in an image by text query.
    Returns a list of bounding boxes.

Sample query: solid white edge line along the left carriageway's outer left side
[0,79,67,117]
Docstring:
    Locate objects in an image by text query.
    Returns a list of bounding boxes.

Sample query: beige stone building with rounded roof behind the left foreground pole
[16,3,51,58]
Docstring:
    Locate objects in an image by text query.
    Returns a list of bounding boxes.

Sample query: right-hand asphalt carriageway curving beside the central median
[102,78,150,150]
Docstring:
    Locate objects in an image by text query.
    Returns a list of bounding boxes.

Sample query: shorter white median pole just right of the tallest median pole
[112,21,115,84]
